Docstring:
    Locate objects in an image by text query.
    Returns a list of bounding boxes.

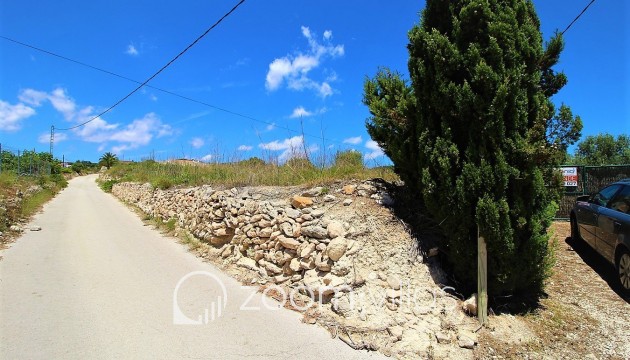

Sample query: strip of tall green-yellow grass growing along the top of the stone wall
[109,154,398,189]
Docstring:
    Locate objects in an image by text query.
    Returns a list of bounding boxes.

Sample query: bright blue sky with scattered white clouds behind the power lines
[0,0,630,165]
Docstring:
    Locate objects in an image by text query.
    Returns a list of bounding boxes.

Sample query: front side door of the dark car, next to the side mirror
[576,184,621,251]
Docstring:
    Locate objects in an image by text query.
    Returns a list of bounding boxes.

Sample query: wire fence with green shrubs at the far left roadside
[0,144,55,176]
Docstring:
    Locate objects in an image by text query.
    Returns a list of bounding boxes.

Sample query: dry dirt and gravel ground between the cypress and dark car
[475,222,630,359]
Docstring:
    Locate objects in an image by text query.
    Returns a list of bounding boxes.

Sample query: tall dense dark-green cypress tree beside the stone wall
[364,0,582,294]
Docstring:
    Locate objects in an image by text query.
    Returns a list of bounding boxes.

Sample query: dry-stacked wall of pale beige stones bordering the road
[112,183,382,289]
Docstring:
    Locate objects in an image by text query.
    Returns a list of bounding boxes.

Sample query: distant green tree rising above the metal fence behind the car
[575,134,630,165]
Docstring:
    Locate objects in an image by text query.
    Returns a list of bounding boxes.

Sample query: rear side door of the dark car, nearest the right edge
[596,185,630,263]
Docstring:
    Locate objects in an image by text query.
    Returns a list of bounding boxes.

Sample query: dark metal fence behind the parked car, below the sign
[556,165,630,220]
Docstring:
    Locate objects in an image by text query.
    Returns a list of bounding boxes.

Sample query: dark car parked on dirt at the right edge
[571,179,630,295]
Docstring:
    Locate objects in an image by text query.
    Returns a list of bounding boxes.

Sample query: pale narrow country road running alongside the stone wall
[0,176,380,359]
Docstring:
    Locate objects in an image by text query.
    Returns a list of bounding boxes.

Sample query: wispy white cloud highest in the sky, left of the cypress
[265,26,345,98]
